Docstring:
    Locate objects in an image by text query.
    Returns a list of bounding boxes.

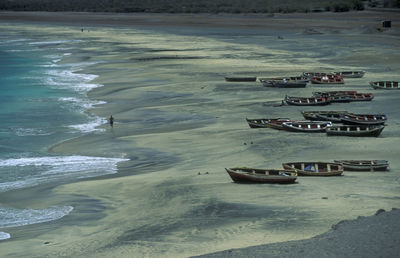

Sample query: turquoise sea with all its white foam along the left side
[0,32,127,240]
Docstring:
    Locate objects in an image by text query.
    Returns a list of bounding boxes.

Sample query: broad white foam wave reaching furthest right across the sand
[0,156,128,192]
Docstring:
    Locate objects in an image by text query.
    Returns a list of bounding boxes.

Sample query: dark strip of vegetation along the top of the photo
[0,0,400,13]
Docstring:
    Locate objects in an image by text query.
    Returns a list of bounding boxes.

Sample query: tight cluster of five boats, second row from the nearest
[246,111,387,137]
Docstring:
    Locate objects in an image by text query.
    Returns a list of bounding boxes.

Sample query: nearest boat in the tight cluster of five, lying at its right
[326,125,385,137]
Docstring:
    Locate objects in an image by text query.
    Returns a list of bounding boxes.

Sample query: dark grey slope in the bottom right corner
[192,208,400,258]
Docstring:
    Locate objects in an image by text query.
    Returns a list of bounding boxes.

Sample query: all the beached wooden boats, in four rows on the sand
[225,71,399,184]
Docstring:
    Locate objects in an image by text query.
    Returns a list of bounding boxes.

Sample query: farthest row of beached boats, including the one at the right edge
[225,71,400,90]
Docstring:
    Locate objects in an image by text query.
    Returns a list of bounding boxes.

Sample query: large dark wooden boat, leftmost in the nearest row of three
[225,168,297,184]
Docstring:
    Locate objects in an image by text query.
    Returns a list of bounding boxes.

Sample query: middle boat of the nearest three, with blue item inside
[282,162,343,176]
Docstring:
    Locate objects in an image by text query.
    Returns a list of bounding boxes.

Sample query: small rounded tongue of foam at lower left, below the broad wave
[0,206,73,228]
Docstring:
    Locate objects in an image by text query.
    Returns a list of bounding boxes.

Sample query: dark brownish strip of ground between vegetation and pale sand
[0,10,399,30]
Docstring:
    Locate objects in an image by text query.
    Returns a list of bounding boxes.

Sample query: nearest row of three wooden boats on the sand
[225,160,389,184]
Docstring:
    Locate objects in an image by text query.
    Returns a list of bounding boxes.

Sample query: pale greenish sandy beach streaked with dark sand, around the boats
[0,11,400,257]
